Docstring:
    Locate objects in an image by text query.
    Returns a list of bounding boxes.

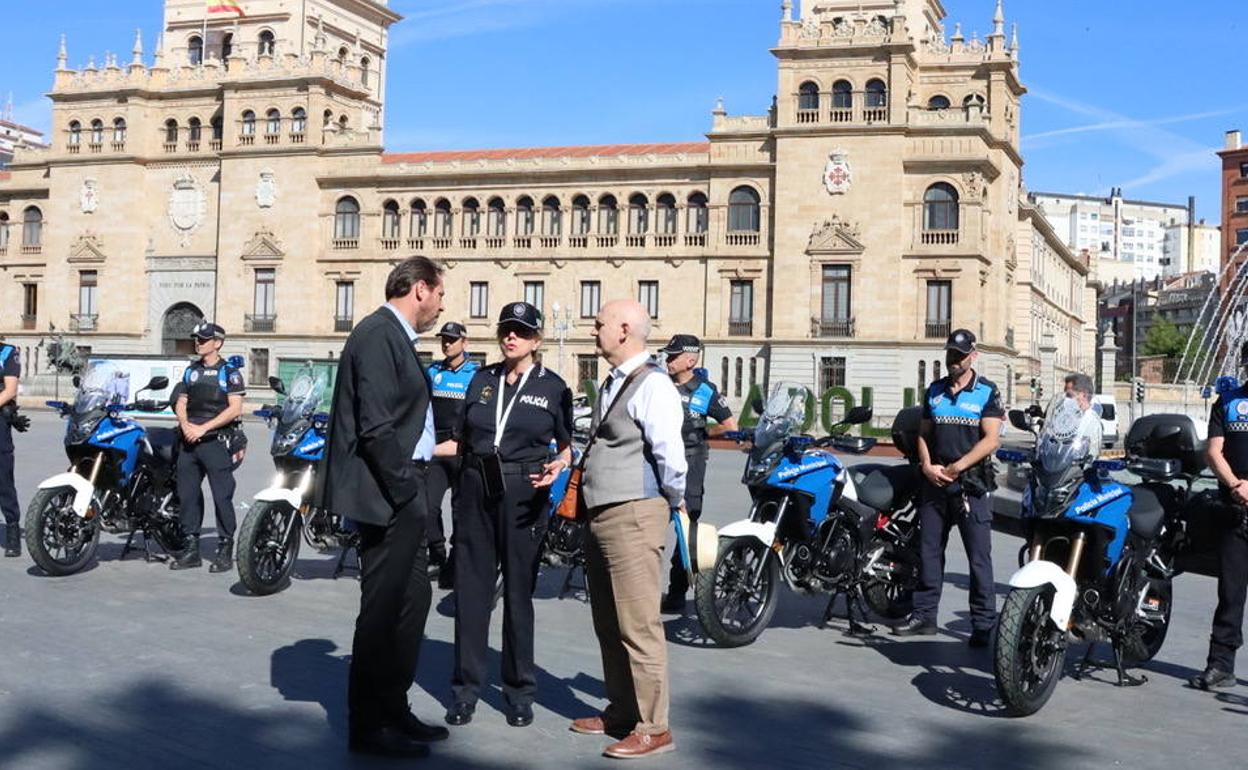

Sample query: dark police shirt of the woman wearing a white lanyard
[458,363,572,463]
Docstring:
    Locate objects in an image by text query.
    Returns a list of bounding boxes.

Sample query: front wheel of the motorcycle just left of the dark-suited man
[237,502,303,597]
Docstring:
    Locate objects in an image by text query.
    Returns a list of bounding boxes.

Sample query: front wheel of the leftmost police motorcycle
[26,487,100,578]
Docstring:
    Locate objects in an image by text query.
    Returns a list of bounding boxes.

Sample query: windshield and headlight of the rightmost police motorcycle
[1032,397,1101,514]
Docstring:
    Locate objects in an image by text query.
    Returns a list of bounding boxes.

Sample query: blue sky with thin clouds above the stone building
[0,0,1248,222]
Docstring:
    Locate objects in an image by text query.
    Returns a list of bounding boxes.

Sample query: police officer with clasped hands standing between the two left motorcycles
[170,322,247,572]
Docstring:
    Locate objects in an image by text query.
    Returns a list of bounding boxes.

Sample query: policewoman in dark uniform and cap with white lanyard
[447,302,572,728]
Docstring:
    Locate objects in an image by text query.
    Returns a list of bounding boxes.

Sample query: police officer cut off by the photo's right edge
[1191,386,1248,690]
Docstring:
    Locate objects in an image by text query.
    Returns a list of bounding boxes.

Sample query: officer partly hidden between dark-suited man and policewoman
[428,322,480,589]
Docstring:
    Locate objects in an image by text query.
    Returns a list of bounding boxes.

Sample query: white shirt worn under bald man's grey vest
[598,353,689,508]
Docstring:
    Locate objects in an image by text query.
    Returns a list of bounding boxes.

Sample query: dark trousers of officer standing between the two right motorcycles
[914,479,997,630]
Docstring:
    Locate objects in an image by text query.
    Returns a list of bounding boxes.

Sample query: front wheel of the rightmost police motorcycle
[992,585,1066,716]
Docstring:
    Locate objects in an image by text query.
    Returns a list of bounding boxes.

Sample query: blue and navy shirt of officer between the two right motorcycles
[924,372,1006,465]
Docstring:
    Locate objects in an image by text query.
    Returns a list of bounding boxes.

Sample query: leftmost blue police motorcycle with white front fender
[26,361,185,577]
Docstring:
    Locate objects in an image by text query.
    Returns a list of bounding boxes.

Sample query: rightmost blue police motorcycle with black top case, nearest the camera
[993,398,1178,716]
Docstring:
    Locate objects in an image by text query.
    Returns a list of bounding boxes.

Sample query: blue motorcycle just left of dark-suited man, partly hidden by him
[237,364,358,597]
